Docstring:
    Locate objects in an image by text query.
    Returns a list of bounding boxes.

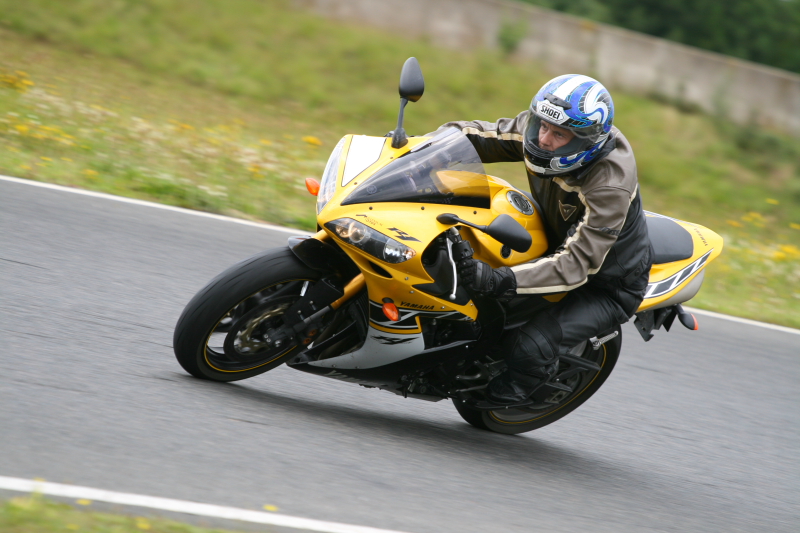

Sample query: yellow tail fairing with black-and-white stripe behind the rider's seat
[637,215,723,312]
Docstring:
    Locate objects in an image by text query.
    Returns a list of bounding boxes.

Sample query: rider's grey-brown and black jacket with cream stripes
[442,111,652,295]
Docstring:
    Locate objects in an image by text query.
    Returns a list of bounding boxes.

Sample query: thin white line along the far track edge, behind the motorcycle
[0,175,800,335]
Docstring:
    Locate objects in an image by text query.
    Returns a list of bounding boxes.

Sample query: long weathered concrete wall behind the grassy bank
[294,0,800,135]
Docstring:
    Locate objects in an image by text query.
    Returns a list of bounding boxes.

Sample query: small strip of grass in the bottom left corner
[0,495,244,533]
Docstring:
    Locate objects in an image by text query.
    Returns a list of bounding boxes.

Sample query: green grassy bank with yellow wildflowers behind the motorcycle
[0,0,800,327]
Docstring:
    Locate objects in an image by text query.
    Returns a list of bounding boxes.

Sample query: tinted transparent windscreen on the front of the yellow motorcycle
[342,128,491,209]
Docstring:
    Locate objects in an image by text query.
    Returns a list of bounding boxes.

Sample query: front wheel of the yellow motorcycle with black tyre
[173,248,321,381]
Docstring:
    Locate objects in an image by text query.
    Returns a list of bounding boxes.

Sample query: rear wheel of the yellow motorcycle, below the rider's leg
[453,328,622,435]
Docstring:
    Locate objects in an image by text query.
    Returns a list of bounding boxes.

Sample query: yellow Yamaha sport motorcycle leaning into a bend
[174,58,722,434]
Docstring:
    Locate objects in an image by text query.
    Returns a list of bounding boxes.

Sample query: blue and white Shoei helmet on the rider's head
[525,74,614,177]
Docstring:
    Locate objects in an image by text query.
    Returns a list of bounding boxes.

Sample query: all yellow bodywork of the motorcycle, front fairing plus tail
[318,135,722,324]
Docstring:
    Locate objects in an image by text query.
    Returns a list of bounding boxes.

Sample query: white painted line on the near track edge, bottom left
[0,476,412,533]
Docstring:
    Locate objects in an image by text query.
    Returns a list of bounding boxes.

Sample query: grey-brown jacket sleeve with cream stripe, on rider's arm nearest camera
[511,170,638,294]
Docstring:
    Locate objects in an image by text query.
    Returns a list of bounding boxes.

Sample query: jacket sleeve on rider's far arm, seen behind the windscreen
[439,111,528,163]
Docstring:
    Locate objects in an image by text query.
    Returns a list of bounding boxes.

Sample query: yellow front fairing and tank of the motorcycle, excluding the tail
[318,136,547,333]
